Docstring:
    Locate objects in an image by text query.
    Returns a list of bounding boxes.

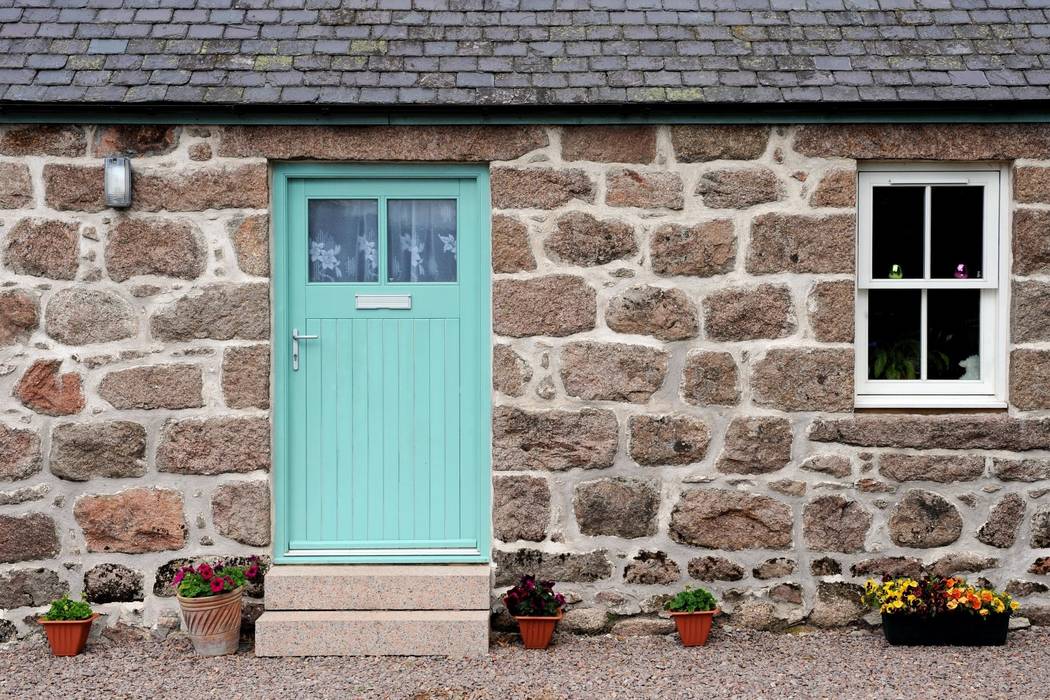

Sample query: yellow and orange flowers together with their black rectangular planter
[861,576,1017,646]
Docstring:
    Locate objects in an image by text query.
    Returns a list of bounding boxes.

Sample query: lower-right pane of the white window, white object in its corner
[926,290,981,380]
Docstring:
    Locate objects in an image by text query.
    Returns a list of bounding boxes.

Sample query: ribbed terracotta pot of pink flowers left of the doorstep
[171,556,261,656]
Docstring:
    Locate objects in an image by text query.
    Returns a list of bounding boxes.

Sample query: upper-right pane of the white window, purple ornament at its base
[929,187,984,279]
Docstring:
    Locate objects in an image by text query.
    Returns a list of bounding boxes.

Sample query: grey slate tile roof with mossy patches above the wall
[0,0,1050,106]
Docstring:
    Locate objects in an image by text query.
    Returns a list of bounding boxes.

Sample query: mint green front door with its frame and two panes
[274,164,490,563]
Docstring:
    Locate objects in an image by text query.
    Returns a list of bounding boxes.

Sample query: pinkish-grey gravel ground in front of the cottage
[0,629,1050,700]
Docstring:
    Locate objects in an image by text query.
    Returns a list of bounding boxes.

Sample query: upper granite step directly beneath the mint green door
[266,564,491,611]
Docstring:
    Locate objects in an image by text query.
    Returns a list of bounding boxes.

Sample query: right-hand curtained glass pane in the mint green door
[386,199,457,282]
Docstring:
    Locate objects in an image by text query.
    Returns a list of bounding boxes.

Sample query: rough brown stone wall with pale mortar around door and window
[0,125,1050,637]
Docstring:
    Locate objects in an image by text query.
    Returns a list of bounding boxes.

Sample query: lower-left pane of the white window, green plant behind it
[867,290,922,380]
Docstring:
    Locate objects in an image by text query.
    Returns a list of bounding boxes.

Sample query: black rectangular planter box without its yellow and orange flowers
[882,613,1010,646]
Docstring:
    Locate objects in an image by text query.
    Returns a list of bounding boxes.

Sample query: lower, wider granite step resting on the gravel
[255,612,488,657]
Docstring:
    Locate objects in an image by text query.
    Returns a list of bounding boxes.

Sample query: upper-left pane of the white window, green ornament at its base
[872,187,926,279]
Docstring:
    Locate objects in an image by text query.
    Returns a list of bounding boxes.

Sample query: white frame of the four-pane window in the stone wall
[854,163,1010,408]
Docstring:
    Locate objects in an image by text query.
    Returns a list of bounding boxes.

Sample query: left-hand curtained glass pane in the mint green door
[307,199,379,282]
